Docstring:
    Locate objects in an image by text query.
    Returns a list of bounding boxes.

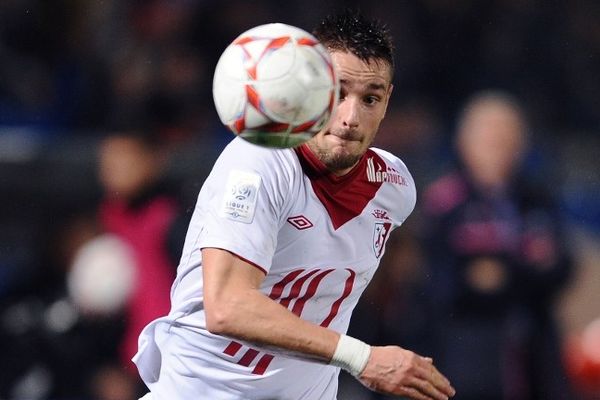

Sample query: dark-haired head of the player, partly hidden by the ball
[308,11,394,174]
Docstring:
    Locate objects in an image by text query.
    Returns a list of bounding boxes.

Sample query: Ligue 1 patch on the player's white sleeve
[220,170,261,224]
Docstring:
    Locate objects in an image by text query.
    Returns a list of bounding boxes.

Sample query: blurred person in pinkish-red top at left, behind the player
[98,122,188,376]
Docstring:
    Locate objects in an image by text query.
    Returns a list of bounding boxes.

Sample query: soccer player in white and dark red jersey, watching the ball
[134,12,454,400]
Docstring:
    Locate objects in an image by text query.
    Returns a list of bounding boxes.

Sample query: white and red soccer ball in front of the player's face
[213,23,339,148]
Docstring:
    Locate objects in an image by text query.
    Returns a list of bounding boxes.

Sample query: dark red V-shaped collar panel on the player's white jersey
[295,144,386,229]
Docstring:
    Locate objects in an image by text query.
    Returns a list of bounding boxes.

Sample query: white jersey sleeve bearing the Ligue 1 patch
[196,138,294,273]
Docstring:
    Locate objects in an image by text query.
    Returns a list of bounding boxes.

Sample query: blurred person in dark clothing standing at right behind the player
[424,92,571,400]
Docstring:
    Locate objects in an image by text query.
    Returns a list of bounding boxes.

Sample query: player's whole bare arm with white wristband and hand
[202,248,454,400]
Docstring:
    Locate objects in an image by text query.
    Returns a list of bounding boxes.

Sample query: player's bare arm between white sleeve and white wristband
[202,249,339,362]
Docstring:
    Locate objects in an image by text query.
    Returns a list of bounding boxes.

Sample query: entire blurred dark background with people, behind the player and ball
[0,0,600,400]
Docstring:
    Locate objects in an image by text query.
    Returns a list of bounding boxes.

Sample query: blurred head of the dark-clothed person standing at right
[456,91,527,186]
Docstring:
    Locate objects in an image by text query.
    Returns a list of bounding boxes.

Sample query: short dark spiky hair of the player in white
[313,9,394,74]
